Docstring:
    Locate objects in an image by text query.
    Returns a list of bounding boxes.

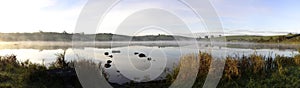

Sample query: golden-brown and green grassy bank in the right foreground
[167,52,300,88]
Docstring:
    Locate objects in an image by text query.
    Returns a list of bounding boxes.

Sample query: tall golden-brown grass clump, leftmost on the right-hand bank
[166,52,213,87]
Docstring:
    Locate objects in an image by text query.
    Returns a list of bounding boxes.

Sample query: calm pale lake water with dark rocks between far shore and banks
[0,41,299,84]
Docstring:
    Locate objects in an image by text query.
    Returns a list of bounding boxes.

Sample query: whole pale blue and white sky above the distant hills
[0,0,300,34]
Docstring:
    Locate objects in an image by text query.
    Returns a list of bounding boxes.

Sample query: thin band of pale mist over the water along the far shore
[0,42,300,51]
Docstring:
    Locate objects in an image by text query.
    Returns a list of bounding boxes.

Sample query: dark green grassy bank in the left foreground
[0,55,81,88]
